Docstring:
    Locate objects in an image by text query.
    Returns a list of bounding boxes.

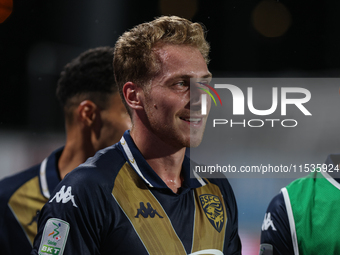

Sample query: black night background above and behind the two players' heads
[0,0,340,131]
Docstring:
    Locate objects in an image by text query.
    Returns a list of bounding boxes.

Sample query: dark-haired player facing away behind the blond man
[0,47,131,255]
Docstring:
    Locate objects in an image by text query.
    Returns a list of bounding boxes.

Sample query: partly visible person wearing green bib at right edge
[260,154,340,255]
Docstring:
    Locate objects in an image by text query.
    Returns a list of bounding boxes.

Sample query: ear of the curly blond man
[123,81,144,110]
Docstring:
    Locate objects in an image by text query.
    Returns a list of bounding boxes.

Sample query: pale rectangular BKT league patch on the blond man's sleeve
[39,218,70,255]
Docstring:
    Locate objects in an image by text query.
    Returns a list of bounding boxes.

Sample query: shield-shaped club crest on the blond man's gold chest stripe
[199,194,225,232]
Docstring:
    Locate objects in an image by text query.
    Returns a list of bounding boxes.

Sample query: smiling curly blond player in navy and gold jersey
[31,16,241,255]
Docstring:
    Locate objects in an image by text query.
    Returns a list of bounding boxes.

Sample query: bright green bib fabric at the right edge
[287,172,340,255]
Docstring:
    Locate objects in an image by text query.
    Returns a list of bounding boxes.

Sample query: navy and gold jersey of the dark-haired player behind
[0,148,62,255]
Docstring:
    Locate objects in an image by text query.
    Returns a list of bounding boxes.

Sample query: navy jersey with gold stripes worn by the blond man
[31,131,241,255]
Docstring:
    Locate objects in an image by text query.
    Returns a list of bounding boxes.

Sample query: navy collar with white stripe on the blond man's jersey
[119,130,206,194]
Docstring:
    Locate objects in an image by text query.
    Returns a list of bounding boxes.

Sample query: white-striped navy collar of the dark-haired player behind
[39,147,64,199]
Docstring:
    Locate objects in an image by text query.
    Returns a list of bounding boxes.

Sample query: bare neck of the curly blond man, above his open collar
[130,128,185,193]
